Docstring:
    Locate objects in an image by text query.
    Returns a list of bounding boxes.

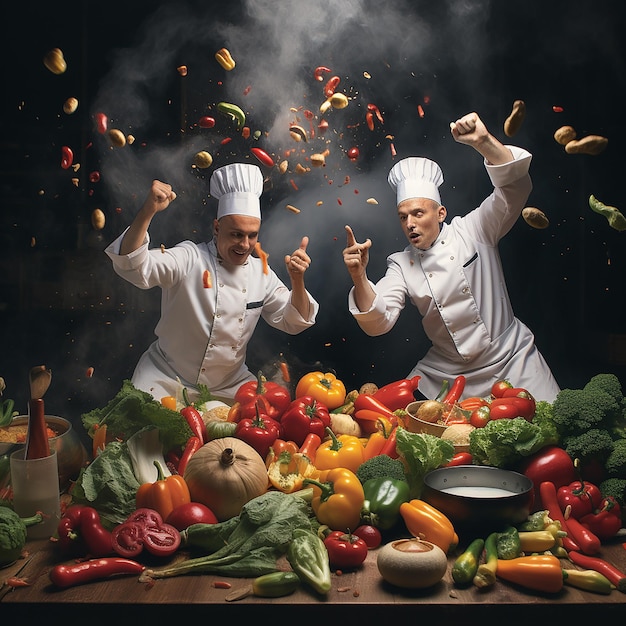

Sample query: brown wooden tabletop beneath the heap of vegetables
[0,536,626,626]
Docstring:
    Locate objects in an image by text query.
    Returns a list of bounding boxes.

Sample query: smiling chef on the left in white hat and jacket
[106,163,319,401]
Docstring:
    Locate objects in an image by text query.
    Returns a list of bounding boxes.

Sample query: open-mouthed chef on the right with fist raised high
[343,112,559,402]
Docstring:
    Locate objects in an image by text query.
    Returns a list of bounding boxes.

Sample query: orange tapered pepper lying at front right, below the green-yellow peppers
[496,554,563,593]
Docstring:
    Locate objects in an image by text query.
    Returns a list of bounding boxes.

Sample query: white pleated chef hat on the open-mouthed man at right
[387,157,443,205]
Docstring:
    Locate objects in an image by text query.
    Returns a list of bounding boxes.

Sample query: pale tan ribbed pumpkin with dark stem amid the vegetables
[184,437,268,522]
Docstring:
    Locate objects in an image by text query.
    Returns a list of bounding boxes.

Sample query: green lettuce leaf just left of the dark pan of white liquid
[396,426,454,498]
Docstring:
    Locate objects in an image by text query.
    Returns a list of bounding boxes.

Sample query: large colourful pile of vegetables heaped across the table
[4,371,626,601]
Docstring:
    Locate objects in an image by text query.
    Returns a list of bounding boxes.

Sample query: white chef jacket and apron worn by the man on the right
[348,146,559,402]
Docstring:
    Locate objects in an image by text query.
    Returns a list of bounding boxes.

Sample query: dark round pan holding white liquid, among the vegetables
[422,465,534,536]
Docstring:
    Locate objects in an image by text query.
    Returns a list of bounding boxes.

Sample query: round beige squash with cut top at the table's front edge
[376,537,448,589]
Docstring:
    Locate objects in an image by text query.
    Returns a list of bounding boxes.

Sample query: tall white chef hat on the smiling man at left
[210,163,263,219]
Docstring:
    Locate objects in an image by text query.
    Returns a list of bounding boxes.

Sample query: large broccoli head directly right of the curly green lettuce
[552,385,622,437]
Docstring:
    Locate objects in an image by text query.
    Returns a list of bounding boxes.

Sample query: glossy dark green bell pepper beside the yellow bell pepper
[361,477,410,530]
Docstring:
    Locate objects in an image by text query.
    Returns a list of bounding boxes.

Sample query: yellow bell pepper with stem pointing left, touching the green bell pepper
[303,467,365,532]
